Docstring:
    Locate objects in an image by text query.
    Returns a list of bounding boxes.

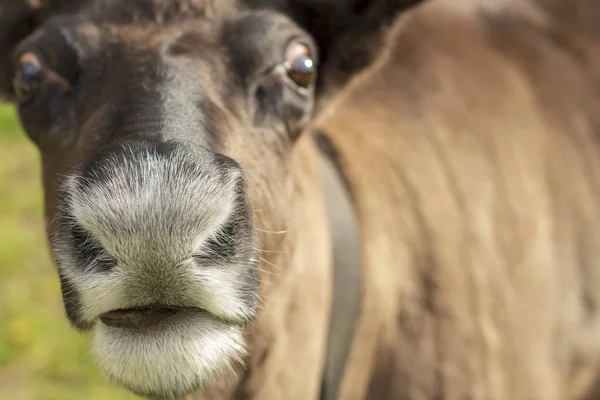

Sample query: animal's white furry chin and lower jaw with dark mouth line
[93,305,246,399]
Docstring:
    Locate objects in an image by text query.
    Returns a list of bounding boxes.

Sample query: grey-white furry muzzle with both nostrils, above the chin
[56,143,259,329]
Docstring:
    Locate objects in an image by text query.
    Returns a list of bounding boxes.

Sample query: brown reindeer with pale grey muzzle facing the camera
[0,0,600,400]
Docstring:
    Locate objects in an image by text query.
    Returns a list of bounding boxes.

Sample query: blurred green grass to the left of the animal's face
[0,106,137,400]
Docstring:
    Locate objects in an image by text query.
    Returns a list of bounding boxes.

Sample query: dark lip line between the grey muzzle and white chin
[100,307,203,329]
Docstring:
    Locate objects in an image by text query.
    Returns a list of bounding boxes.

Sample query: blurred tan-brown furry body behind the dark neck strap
[312,1,600,399]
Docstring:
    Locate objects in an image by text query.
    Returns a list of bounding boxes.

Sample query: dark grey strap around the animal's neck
[316,134,362,400]
